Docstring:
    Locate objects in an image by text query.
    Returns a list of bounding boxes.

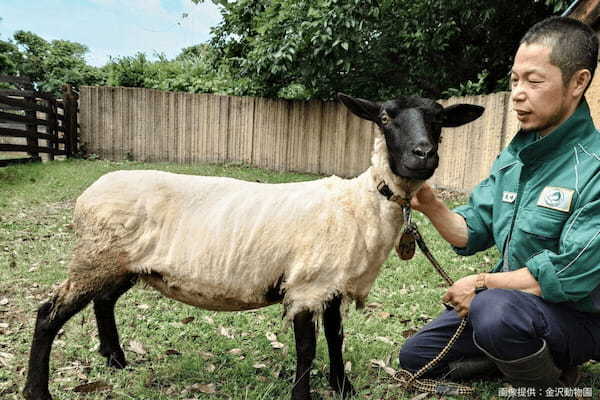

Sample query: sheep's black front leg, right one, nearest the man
[323,296,356,398]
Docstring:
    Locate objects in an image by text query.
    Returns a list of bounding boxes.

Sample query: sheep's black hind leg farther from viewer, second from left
[94,276,137,368]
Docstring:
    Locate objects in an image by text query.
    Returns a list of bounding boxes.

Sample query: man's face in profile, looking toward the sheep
[511,43,577,136]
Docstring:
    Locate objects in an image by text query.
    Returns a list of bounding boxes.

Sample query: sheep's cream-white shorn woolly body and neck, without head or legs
[75,135,418,319]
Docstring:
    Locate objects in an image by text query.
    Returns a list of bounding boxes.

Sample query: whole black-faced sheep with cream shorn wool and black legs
[23,94,483,400]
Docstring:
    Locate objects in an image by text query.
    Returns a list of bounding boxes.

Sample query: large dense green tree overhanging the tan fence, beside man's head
[197,0,566,99]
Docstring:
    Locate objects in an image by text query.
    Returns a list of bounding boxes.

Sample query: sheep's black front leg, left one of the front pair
[292,311,317,400]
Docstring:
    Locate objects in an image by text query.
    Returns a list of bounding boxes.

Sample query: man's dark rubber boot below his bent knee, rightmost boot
[482,340,562,399]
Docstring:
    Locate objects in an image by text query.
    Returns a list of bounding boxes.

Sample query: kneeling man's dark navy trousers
[400,289,600,377]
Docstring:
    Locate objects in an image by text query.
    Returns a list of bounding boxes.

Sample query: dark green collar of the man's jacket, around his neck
[509,99,596,165]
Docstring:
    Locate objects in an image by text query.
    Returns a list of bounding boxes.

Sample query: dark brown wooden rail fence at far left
[0,76,78,166]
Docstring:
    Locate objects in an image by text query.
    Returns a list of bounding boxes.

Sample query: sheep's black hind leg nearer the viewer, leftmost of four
[23,286,93,400]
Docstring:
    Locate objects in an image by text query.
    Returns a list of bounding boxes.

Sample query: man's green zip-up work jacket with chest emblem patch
[454,100,600,312]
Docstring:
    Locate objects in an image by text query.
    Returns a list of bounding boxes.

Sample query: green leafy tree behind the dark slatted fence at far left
[0,31,104,94]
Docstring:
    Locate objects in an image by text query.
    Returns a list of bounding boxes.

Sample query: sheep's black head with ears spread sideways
[338,93,484,181]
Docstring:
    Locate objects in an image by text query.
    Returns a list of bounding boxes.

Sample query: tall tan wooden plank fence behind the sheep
[80,87,517,191]
